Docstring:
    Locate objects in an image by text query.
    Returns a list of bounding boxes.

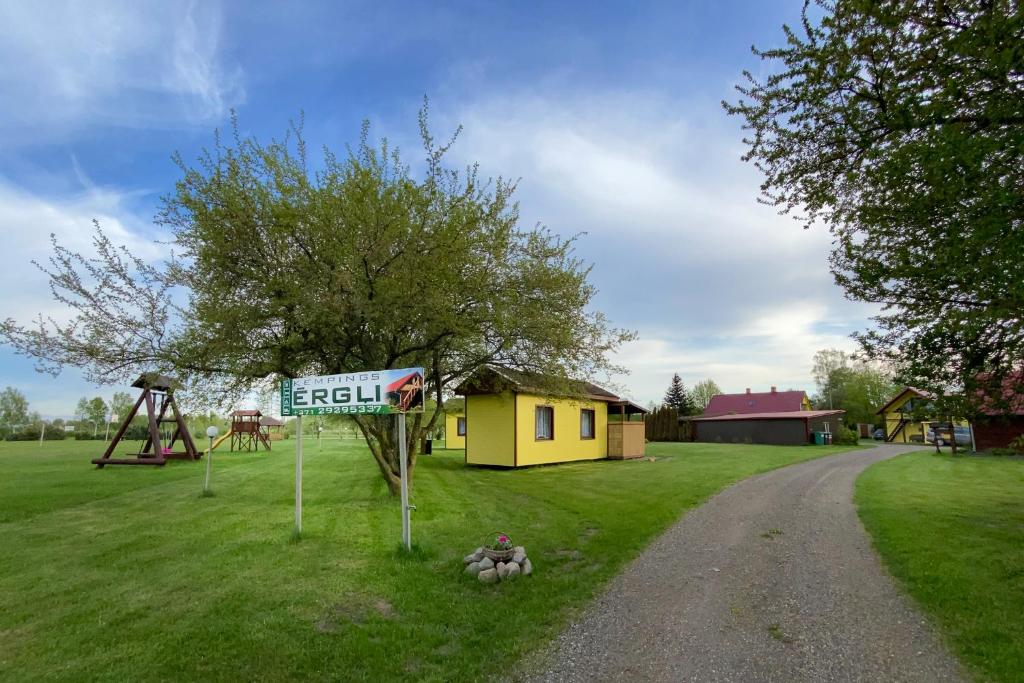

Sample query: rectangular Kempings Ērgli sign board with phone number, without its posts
[281,368,424,416]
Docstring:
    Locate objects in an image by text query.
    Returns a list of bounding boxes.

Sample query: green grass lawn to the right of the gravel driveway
[856,451,1024,681]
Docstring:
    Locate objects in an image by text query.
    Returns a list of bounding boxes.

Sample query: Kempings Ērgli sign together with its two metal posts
[281,368,424,550]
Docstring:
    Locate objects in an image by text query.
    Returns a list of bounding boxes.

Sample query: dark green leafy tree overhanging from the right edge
[725,0,1024,411]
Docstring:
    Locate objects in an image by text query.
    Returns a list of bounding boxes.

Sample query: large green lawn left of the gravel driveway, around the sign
[0,441,847,681]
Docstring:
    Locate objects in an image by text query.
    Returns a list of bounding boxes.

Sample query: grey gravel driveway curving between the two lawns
[538,445,967,681]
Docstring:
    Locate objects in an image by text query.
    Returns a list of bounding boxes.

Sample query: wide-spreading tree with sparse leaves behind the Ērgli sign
[0,109,632,493]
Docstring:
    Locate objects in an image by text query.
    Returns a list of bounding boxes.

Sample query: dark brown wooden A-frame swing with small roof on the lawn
[92,373,203,469]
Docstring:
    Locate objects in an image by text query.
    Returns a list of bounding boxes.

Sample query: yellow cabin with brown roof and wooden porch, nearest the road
[449,366,646,467]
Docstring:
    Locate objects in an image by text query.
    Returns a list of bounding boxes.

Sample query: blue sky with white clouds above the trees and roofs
[0,0,874,417]
